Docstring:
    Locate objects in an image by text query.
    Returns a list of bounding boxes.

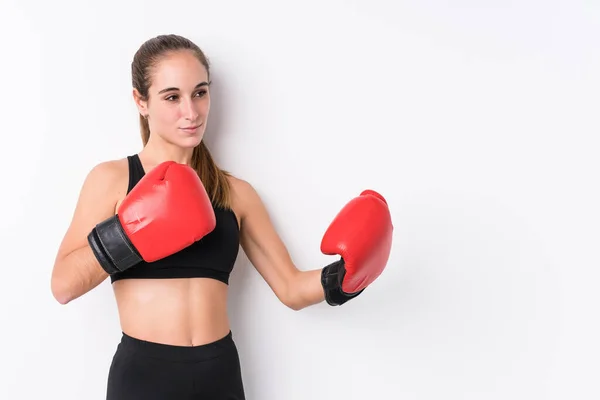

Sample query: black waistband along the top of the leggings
[120,331,235,361]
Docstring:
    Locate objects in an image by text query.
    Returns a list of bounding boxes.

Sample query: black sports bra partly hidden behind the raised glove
[110,154,240,284]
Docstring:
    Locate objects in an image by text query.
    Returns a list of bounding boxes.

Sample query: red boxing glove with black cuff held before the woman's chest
[88,161,216,274]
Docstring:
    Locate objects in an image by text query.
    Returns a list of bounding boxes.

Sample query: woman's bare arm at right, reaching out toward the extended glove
[234,180,324,310]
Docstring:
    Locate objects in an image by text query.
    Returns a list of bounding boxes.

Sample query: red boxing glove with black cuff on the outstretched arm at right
[321,190,394,305]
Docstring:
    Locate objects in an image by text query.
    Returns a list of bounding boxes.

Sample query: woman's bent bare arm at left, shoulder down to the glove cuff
[51,161,119,304]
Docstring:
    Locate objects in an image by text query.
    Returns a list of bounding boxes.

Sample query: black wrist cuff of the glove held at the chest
[88,215,143,275]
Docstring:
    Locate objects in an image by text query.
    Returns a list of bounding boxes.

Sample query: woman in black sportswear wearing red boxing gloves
[52,35,391,400]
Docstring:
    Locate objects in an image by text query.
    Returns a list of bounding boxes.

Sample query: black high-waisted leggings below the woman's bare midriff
[106,332,245,400]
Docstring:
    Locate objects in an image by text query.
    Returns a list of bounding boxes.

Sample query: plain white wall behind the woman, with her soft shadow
[0,0,600,400]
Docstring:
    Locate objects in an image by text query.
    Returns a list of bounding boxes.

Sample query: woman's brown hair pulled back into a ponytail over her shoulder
[131,35,231,208]
